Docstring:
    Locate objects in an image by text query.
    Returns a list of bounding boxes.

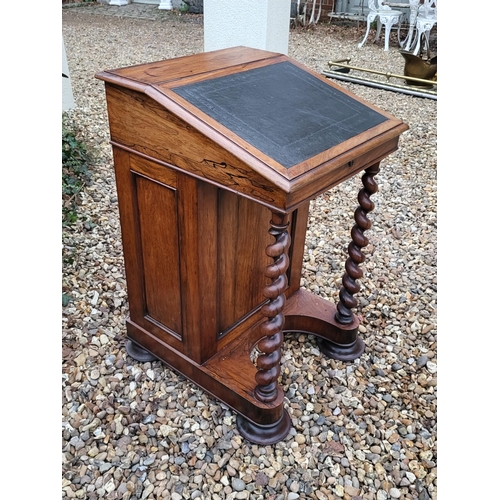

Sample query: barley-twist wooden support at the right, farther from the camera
[335,164,379,325]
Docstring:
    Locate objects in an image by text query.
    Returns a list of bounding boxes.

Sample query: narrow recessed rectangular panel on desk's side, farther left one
[136,176,182,337]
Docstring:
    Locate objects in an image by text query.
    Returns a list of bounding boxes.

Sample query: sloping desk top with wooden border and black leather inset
[96,47,408,200]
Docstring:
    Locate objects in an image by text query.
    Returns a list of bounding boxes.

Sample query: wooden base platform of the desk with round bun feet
[127,288,364,445]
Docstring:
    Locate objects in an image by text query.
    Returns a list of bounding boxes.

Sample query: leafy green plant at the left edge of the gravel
[62,115,91,224]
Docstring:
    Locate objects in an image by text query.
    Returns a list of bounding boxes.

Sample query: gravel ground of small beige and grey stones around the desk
[62,5,437,500]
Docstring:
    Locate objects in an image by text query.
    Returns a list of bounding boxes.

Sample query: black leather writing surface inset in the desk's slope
[173,62,387,168]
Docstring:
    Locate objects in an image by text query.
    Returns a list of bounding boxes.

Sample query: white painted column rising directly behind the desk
[203,0,291,54]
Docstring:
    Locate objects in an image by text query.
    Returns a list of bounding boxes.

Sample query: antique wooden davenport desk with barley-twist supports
[96,47,408,444]
